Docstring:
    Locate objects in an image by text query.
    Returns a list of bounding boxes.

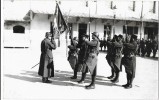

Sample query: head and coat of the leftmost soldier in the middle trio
[67,37,78,70]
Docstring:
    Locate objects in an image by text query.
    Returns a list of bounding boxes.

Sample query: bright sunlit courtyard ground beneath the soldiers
[1,48,158,100]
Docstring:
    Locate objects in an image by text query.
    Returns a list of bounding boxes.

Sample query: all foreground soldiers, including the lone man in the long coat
[38,32,138,89]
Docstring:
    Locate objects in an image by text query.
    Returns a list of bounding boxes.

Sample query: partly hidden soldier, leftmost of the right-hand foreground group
[105,35,117,79]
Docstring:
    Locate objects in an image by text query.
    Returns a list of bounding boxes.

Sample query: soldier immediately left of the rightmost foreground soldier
[111,35,123,83]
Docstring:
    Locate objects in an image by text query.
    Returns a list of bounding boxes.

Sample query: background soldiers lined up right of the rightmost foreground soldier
[138,39,158,58]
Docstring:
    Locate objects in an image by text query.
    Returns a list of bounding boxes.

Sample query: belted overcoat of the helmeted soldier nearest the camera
[86,39,100,75]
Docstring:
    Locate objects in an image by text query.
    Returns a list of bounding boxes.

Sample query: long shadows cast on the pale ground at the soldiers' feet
[5,70,121,87]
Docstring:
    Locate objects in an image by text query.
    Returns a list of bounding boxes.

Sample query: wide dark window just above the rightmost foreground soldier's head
[123,26,138,35]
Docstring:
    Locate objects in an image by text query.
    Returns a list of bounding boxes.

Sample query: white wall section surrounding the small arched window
[3,21,30,47]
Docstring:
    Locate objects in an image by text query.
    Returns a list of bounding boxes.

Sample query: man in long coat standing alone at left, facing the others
[38,32,56,83]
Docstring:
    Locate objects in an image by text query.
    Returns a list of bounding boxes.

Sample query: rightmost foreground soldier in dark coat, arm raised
[121,35,137,89]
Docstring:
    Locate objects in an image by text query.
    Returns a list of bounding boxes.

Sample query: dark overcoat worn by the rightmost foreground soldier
[122,41,137,77]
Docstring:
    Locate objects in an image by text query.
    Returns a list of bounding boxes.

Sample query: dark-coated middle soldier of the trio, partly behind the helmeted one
[71,34,88,79]
